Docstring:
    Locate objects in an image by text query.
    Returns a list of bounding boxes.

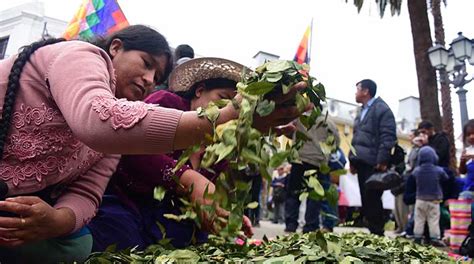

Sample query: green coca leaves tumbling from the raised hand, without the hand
[163,60,337,238]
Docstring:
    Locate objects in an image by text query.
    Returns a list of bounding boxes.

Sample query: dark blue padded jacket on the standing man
[349,97,397,166]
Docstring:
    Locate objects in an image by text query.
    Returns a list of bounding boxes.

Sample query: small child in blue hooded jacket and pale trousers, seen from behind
[413,146,448,247]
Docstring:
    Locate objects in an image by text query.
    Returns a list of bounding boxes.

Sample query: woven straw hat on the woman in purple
[168,57,248,92]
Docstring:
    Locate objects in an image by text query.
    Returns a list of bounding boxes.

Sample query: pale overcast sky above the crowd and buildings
[0,0,474,135]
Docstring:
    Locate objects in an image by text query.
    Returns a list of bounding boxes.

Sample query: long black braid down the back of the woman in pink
[0,38,64,160]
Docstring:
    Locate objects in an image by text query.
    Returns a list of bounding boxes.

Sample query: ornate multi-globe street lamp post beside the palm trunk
[428,32,474,126]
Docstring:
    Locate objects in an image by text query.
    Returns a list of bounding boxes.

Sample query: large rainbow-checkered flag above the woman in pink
[63,0,129,40]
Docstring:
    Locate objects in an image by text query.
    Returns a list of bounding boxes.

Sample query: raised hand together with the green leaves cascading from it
[173,61,325,236]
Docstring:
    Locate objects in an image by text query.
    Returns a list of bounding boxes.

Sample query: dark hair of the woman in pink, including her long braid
[0,25,173,160]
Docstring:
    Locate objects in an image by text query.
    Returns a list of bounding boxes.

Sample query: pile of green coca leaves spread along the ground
[86,231,454,264]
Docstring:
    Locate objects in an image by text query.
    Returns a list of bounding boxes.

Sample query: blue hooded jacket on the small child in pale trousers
[413,146,449,201]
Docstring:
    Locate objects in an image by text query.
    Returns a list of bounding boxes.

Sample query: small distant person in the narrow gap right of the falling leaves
[271,165,287,224]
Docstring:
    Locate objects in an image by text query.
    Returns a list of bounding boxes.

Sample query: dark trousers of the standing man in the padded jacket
[353,163,385,235]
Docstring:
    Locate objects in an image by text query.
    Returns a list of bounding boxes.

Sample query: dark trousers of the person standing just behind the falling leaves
[285,162,335,233]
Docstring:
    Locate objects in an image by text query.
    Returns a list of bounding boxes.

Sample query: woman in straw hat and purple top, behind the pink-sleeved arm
[89,58,252,251]
